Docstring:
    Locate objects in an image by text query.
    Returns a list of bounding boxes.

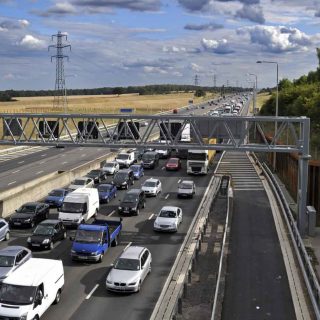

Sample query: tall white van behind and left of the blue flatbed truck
[59,188,100,227]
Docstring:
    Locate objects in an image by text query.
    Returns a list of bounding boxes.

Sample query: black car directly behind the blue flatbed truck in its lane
[118,189,146,215]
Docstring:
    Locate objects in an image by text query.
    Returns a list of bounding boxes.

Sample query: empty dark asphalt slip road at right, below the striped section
[222,191,296,320]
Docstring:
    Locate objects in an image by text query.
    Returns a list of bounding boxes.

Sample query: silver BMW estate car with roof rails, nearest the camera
[106,246,152,293]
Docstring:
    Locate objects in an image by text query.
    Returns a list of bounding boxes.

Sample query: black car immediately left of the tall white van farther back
[9,202,49,228]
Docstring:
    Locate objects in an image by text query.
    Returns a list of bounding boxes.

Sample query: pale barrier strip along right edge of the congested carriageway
[150,176,220,320]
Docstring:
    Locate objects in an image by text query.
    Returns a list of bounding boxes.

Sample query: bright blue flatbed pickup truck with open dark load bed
[70,218,122,262]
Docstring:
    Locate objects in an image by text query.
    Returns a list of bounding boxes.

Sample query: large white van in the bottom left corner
[0,258,64,320]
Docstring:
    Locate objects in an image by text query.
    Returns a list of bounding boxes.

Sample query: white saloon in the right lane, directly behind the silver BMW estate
[153,206,182,232]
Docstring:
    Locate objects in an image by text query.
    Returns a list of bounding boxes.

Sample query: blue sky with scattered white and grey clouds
[0,0,320,90]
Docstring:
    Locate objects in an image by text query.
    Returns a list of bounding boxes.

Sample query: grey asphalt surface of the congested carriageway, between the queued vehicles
[0,156,211,319]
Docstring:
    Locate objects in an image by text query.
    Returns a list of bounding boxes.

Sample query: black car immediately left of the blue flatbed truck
[27,219,67,249]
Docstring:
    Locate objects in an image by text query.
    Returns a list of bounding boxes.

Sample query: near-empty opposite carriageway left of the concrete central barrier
[0,147,114,191]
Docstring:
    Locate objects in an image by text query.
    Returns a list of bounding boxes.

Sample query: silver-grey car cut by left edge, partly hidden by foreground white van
[0,246,32,281]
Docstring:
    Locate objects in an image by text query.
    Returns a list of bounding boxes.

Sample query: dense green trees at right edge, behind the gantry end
[260,49,320,159]
